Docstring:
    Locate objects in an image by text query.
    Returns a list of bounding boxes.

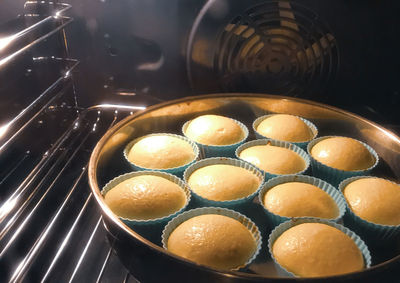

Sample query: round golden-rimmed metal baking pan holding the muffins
[89,94,400,282]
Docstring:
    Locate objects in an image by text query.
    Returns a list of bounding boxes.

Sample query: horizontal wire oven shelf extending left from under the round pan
[0,105,142,282]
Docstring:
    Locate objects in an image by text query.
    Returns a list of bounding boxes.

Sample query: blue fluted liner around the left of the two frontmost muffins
[161,207,262,270]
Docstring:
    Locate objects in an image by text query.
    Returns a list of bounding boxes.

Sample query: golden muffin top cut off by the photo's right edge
[343,178,400,225]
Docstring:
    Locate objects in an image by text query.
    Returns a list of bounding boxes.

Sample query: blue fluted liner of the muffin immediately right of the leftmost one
[183,157,264,212]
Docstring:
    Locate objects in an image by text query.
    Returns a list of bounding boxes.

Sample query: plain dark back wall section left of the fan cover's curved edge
[67,0,205,105]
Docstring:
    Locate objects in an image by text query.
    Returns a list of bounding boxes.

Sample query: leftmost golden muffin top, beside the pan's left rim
[104,175,186,220]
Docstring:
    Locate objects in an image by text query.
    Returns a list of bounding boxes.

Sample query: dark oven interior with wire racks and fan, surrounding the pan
[0,0,400,282]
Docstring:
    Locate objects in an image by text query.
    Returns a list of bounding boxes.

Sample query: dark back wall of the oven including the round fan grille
[67,0,400,126]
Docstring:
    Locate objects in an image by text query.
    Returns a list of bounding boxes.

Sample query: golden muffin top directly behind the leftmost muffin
[128,134,196,169]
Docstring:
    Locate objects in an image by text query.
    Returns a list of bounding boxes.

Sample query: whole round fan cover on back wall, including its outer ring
[187,1,339,96]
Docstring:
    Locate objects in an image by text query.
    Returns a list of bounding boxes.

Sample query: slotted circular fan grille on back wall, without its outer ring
[214,1,339,95]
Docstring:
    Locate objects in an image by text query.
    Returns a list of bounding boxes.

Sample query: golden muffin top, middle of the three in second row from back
[239,144,306,174]
